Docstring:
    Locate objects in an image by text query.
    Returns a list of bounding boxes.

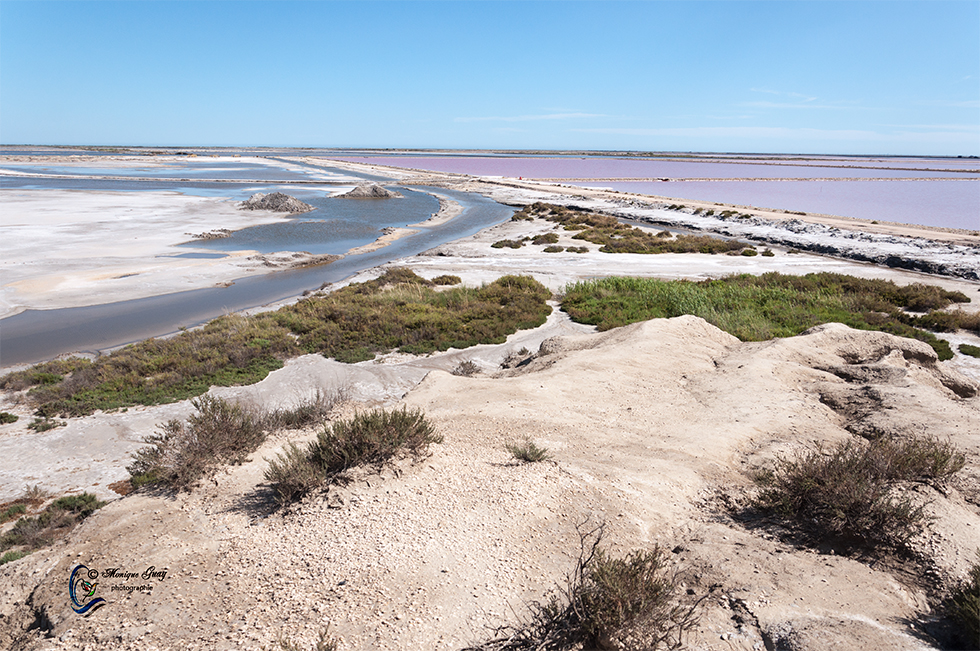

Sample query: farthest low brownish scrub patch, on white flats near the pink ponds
[510,203,745,253]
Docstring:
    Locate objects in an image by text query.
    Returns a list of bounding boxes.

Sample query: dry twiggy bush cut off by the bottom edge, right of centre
[464,528,700,651]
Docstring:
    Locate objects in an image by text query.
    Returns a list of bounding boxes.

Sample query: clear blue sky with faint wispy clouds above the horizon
[0,0,980,155]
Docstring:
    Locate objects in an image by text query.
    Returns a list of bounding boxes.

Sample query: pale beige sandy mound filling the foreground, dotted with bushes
[0,316,980,651]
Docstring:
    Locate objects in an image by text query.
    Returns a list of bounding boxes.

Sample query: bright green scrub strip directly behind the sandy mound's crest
[562,273,972,360]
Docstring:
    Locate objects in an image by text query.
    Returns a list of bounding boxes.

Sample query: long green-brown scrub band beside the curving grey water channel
[0,269,551,418]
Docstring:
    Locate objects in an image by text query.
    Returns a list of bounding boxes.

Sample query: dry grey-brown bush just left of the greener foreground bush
[126,395,266,491]
